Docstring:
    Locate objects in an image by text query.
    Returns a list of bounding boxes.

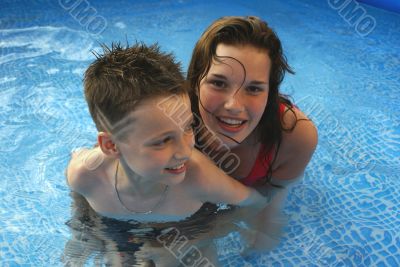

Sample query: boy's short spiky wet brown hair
[84,42,187,131]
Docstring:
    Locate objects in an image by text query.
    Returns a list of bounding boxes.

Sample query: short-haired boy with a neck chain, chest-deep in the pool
[67,44,267,222]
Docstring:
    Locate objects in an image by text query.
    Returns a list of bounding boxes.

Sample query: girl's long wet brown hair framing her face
[187,16,296,184]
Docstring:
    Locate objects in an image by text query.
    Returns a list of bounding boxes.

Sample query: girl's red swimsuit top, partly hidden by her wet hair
[240,103,286,186]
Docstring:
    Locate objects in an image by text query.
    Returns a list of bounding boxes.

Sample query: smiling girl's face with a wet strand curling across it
[199,44,271,147]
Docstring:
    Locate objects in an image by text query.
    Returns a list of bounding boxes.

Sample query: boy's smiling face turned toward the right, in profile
[115,95,194,184]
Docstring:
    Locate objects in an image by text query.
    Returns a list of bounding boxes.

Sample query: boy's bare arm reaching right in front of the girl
[187,149,270,209]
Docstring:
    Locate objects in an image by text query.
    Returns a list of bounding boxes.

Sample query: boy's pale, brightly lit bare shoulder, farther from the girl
[66,147,107,196]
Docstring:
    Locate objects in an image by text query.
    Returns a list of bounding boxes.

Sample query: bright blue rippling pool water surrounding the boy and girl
[0,0,400,266]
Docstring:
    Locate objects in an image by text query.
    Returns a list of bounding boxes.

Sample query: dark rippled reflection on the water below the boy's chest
[63,192,235,266]
